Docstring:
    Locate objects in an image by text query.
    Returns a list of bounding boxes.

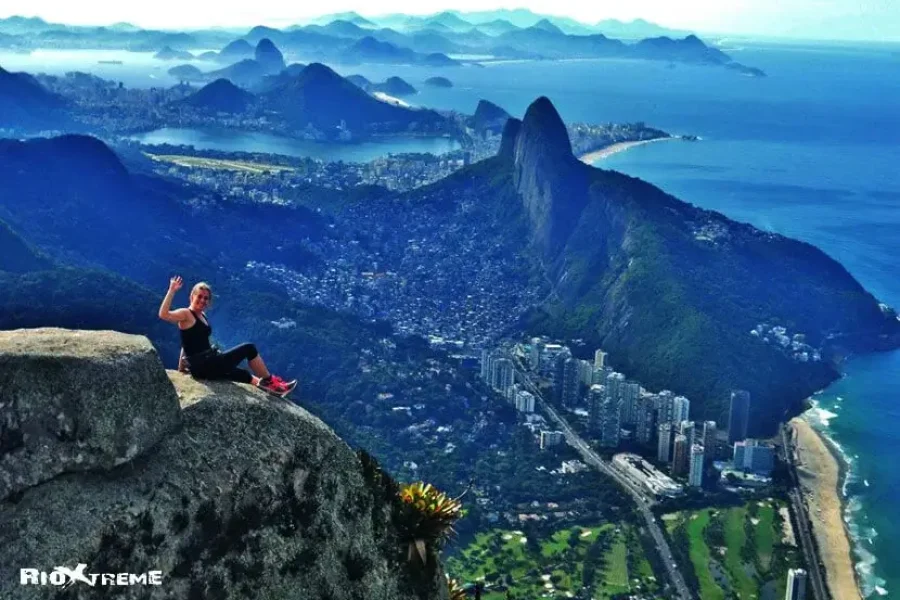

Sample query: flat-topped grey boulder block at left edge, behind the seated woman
[0,329,181,500]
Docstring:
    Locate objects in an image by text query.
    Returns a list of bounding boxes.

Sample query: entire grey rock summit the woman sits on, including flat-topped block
[0,330,447,600]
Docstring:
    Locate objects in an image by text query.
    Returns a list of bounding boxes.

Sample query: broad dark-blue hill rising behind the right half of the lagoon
[263,63,447,134]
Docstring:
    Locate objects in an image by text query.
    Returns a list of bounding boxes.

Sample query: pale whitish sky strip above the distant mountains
[0,0,900,41]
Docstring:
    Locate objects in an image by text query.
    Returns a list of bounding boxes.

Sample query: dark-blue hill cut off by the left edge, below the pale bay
[0,67,70,131]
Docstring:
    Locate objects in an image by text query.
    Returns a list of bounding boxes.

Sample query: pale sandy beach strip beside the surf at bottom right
[791,417,862,600]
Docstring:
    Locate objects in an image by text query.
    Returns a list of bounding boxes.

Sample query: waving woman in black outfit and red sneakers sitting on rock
[159,276,297,397]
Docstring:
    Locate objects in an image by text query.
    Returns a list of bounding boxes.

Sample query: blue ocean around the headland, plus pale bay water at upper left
[0,42,900,597]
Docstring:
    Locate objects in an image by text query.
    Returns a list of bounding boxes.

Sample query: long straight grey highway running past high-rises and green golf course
[516,359,693,600]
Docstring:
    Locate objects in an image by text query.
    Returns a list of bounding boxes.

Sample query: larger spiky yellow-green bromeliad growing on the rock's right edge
[400,481,468,564]
